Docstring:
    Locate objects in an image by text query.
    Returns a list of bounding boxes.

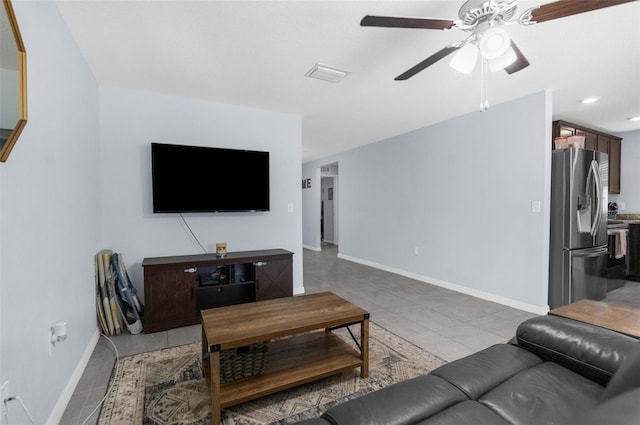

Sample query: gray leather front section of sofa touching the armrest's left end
[431,344,542,400]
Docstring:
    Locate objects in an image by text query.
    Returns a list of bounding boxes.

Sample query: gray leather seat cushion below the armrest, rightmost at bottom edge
[479,362,604,425]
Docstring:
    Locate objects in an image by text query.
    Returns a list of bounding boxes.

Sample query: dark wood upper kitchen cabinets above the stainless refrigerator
[551,120,622,194]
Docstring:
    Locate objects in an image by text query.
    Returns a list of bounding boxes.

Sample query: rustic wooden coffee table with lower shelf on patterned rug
[201,292,369,425]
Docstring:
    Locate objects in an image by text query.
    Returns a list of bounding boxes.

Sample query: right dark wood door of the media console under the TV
[255,258,293,301]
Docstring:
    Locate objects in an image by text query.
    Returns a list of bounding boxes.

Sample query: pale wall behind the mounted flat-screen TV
[100,87,302,295]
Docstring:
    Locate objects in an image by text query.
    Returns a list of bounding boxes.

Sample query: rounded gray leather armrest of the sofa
[516,315,638,385]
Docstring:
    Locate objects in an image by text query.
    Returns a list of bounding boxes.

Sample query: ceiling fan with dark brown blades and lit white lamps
[360,0,637,80]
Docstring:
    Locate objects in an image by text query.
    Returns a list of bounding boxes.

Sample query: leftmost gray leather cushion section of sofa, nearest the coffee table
[322,375,467,425]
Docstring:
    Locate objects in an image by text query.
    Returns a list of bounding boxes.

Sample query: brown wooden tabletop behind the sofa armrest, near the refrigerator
[549,299,640,338]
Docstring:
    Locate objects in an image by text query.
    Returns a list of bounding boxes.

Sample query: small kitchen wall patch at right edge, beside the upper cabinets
[609,127,640,213]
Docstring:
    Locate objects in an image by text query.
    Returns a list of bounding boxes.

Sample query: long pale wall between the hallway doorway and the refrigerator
[303,93,551,312]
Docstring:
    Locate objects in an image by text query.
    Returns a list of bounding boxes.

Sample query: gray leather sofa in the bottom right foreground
[292,315,640,425]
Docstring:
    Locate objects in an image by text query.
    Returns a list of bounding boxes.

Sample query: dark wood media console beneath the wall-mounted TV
[142,249,293,333]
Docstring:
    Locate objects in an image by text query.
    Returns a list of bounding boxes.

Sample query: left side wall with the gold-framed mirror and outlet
[0,1,101,424]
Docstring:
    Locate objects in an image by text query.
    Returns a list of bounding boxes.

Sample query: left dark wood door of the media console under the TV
[144,265,199,332]
